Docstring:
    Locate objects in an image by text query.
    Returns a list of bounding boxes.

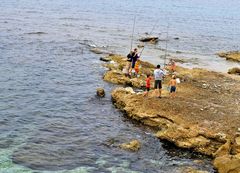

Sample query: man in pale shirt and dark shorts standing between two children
[154,64,165,98]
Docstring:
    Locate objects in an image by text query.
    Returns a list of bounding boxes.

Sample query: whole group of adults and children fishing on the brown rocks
[125,48,177,98]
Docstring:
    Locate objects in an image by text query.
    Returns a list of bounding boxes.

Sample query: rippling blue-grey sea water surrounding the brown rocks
[0,0,240,173]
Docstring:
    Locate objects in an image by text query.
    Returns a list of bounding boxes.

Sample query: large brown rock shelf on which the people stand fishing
[103,55,240,173]
